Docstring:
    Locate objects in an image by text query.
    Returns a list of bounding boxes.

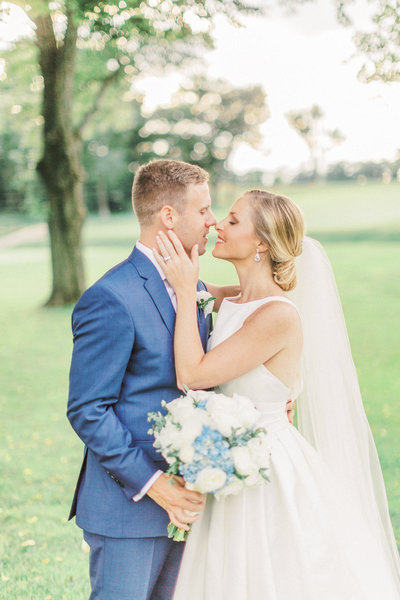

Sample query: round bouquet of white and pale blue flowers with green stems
[148,388,270,541]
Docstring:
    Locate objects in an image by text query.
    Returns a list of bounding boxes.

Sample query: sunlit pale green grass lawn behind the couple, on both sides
[0,180,400,600]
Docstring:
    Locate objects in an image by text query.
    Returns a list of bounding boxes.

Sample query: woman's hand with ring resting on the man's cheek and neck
[153,231,199,295]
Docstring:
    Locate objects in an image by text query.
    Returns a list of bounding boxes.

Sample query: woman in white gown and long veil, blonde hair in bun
[155,191,400,600]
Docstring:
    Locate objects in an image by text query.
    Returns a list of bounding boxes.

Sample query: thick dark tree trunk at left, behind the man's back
[35,15,85,306]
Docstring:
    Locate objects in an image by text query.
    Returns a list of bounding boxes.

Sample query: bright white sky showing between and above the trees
[0,0,400,172]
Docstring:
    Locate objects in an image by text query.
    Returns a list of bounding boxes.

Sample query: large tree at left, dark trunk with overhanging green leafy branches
[3,0,258,304]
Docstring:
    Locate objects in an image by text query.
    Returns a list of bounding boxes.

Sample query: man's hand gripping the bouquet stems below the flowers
[147,473,205,531]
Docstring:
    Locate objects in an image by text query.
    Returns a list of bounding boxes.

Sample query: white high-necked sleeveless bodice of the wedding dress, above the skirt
[208,296,299,432]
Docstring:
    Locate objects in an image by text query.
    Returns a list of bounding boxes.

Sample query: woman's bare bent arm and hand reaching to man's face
[155,232,297,389]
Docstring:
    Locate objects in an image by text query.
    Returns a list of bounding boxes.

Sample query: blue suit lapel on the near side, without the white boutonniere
[128,248,176,336]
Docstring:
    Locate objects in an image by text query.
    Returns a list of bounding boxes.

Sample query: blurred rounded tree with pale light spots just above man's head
[131,77,268,185]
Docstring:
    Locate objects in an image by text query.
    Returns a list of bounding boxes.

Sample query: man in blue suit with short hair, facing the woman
[67,160,225,600]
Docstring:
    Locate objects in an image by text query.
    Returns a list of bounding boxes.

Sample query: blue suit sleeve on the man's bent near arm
[67,286,158,499]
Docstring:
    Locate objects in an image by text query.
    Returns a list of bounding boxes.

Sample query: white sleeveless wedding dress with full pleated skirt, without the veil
[174,297,400,600]
